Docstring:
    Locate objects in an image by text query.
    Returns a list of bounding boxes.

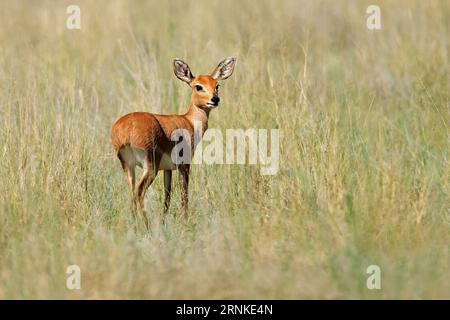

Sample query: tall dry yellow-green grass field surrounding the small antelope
[0,0,450,299]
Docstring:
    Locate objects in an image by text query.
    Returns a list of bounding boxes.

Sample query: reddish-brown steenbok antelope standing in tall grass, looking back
[111,58,236,229]
